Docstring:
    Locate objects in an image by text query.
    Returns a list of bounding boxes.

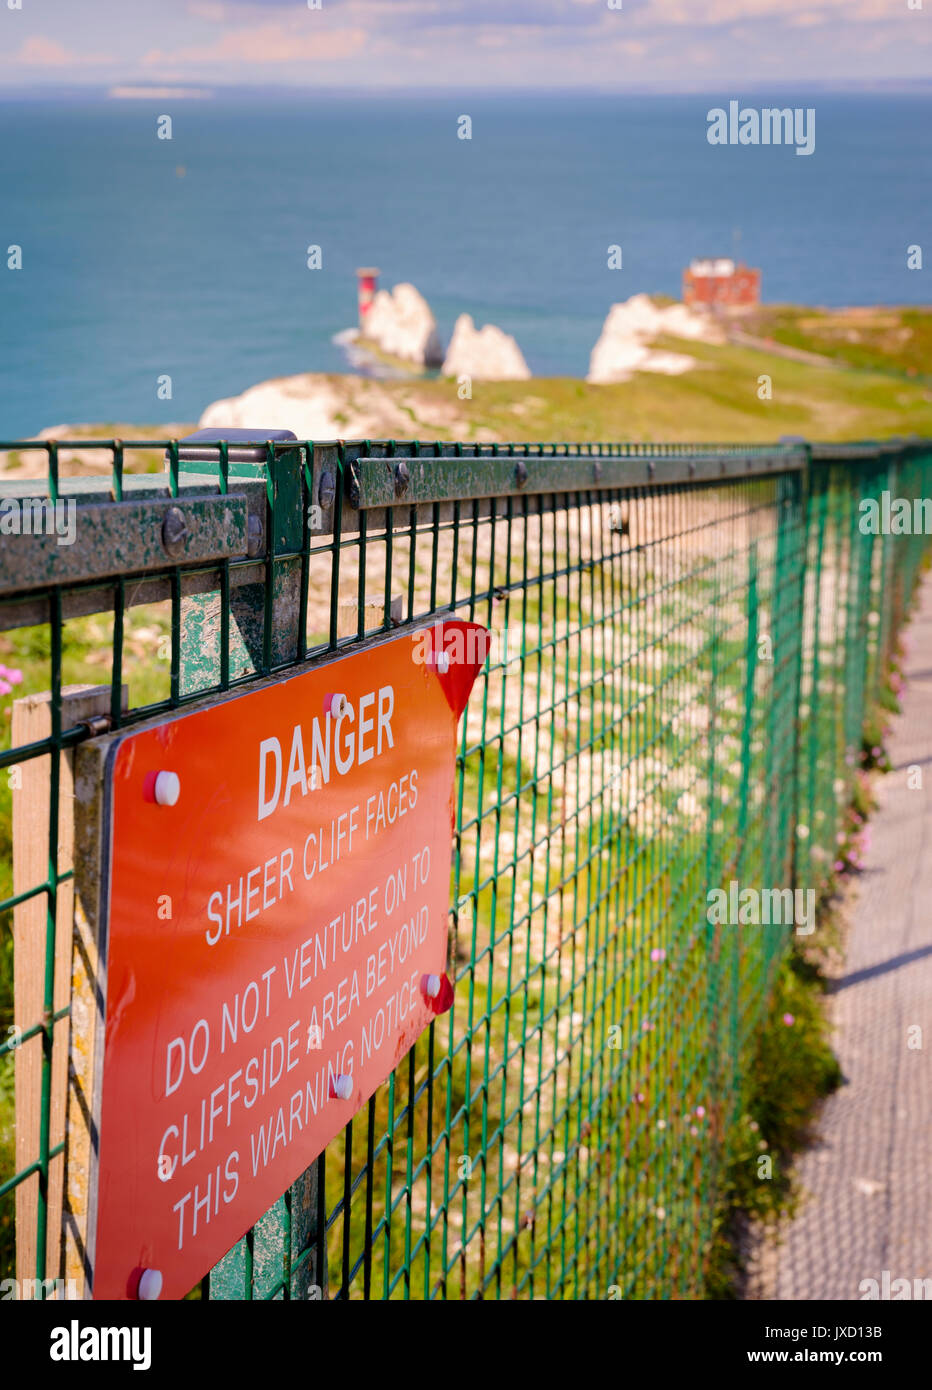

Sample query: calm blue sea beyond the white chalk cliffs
[0,92,932,438]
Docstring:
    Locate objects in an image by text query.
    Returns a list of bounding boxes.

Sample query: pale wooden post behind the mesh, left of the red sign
[11,685,118,1282]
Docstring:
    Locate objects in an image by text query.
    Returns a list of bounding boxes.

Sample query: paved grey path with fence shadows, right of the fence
[746,577,932,1300]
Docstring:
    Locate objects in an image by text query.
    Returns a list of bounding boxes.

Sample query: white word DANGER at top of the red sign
[257,685,394,820]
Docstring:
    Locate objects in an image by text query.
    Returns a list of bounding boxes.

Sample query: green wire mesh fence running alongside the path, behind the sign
[0,441,932,1298]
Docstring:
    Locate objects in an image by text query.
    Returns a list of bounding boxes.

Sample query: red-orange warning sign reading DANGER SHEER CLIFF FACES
[88,621,488,1298]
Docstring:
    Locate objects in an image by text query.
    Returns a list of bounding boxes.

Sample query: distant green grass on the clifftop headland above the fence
[0,322,932,458]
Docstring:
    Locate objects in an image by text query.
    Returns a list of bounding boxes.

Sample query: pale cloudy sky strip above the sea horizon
[0,0,932,92]
